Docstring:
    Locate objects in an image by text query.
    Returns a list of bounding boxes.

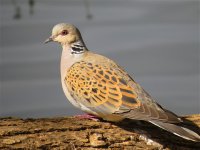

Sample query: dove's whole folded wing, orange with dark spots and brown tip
[65,56,179,122]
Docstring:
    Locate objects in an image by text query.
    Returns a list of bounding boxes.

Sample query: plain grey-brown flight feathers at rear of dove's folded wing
[115,83,181,123]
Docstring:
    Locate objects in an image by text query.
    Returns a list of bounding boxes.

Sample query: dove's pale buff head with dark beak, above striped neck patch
[45,23,82,45]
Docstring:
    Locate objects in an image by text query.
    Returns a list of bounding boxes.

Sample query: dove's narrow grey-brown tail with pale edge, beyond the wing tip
[150,121,200,142]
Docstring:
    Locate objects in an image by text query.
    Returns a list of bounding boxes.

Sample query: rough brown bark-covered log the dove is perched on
[0,114,200,150]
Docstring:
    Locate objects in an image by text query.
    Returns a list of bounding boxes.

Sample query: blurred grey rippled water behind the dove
[0,0,200,118]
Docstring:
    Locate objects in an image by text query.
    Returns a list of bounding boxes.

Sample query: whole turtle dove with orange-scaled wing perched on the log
[45,23,200,142]
